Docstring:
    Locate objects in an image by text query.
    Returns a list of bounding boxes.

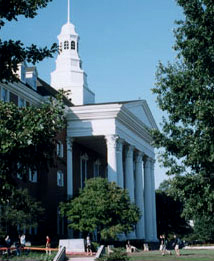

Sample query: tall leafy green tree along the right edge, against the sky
[153,0,214,228]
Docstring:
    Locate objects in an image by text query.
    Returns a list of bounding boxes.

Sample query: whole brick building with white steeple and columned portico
[0,0,157,242]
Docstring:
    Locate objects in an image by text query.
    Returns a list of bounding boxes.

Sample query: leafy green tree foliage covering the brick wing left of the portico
[0,96,64,204]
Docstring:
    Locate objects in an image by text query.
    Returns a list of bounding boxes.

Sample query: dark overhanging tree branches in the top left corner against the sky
[0,0,58,82]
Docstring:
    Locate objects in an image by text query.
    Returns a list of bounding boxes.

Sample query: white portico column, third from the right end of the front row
[135,151,145,239]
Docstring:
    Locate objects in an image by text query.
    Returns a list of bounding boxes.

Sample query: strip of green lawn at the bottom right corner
[130,250,214,261]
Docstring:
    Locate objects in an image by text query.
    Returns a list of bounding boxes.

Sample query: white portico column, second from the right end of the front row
[144,157,152,241]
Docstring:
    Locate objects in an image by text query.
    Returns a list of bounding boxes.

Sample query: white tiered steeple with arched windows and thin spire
[51,0,95,105]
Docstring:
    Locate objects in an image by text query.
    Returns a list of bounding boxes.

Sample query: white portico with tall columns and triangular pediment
[67,100,157,242]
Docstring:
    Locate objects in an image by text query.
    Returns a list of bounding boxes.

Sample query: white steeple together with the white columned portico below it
[51,0,157,241]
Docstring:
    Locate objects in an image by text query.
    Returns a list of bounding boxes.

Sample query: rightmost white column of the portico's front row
[150,156,157,241]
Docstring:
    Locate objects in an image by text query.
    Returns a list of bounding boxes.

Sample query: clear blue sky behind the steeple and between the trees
[1,0,182,187]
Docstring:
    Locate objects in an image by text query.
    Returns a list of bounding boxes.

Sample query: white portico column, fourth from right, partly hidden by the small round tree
[125,145,136,239]
